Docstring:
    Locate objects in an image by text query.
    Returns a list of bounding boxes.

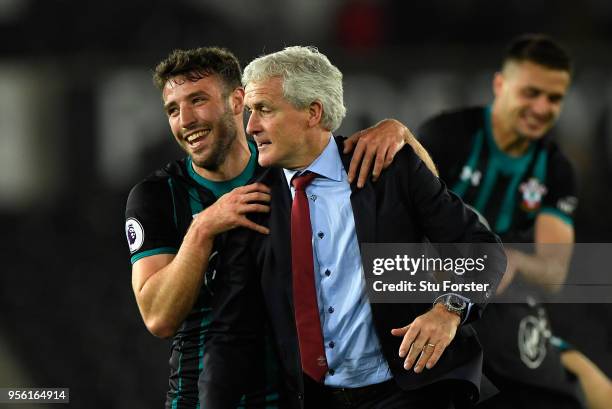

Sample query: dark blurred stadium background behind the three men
[0,0,612,409]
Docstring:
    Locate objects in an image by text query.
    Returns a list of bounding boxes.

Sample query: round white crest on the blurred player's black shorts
[518,315,550,369]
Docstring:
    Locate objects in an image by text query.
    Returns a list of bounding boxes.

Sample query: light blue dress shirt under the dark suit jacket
[284,137,392,388]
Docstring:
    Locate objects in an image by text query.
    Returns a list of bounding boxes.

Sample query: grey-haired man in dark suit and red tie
[213,47,505,408]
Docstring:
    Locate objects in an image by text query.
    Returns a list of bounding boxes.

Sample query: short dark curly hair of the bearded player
[153,47,242,92]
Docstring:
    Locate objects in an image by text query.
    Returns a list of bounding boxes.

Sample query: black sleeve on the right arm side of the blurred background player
[540,151,578,225]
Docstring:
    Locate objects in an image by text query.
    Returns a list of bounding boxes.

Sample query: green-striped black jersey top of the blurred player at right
[417,107,577,243]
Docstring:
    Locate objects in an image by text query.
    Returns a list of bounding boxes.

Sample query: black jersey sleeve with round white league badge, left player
[125,179,181,264]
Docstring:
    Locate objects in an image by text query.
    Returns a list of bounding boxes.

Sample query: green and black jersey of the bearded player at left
[125,143,276,409]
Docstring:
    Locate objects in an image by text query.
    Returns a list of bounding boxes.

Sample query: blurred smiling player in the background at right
[417,35,582,408]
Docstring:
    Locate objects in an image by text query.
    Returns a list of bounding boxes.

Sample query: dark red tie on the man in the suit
[291,173,328,382]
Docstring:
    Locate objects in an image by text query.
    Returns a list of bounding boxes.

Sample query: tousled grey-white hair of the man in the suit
[242,46,346,131]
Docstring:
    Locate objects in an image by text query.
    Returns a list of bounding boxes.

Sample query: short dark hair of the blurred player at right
[502,34,572,74]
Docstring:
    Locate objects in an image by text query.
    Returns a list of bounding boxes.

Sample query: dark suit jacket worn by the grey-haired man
[222,138,505,407]
